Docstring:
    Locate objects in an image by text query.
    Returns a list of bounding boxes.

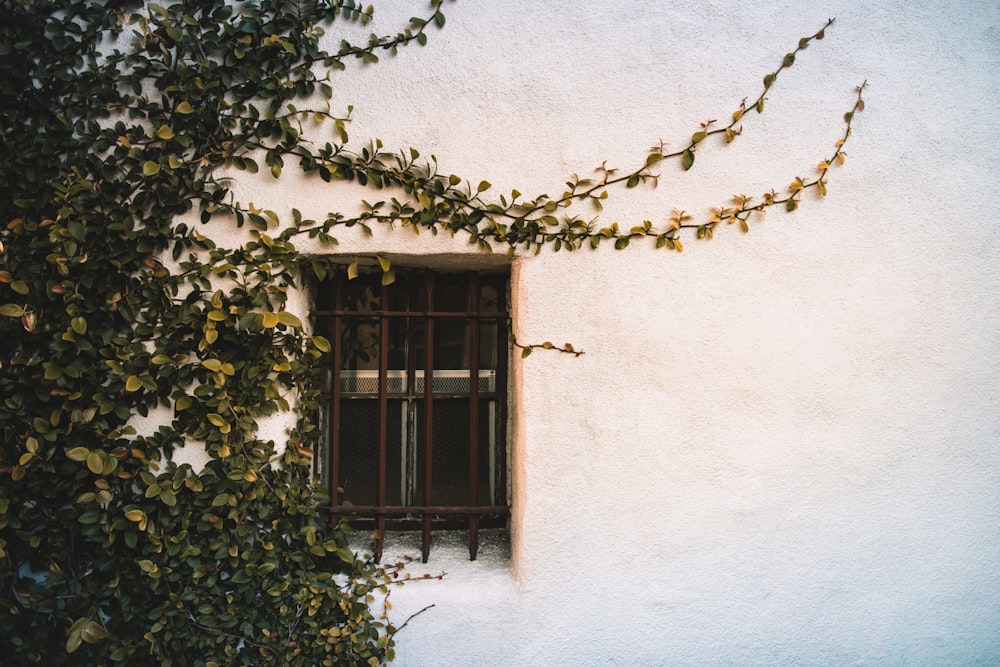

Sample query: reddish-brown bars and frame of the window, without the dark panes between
[312,268,511,563]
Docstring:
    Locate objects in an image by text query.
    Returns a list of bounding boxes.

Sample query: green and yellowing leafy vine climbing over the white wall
[0,0,864,666]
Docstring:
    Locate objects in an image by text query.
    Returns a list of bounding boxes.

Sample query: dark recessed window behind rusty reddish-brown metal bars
[313,270,509,562]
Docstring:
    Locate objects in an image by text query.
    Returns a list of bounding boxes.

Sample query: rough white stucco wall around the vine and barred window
[215,0,1000,666]
